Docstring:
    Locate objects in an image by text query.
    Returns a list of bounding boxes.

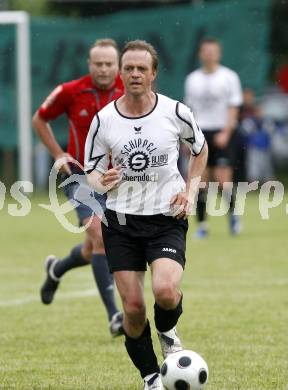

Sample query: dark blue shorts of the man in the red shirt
[62,171,107,226]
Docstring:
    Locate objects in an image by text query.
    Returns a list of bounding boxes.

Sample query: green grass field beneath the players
[0,195,288,390]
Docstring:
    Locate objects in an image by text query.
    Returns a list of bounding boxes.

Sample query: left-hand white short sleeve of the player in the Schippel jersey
[84,114,110,173]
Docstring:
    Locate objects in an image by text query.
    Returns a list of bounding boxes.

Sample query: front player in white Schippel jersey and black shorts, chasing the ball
[85,40,208,389]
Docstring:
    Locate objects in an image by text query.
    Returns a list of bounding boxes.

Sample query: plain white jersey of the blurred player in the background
[184,65,243,130]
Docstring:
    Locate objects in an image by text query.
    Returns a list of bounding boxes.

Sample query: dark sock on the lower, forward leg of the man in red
[92,254,119,321]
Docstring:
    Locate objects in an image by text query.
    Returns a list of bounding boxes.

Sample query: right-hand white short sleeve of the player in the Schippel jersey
[176,102,205,156]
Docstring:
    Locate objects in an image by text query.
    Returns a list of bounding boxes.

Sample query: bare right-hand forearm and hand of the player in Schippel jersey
[171,142,208,219]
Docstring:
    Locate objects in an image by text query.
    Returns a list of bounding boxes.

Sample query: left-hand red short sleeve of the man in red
[38,84,71,121]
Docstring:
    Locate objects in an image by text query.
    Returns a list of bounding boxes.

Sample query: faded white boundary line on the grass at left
[0,289,99,307]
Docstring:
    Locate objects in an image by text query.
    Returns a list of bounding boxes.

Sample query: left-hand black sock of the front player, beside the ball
[125,321,159,378]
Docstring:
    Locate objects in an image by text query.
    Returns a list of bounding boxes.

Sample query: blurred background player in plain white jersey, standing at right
[184,38,242,238]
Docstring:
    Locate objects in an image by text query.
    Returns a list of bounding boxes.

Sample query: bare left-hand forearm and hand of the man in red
[32,111,71,175]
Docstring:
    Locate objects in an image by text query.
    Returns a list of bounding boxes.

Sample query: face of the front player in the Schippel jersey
[120,50,157,96]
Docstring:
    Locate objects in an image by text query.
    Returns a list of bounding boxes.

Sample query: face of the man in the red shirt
[88,46,118,89]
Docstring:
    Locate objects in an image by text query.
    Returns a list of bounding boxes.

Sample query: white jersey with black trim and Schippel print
[85,94,205,215]
